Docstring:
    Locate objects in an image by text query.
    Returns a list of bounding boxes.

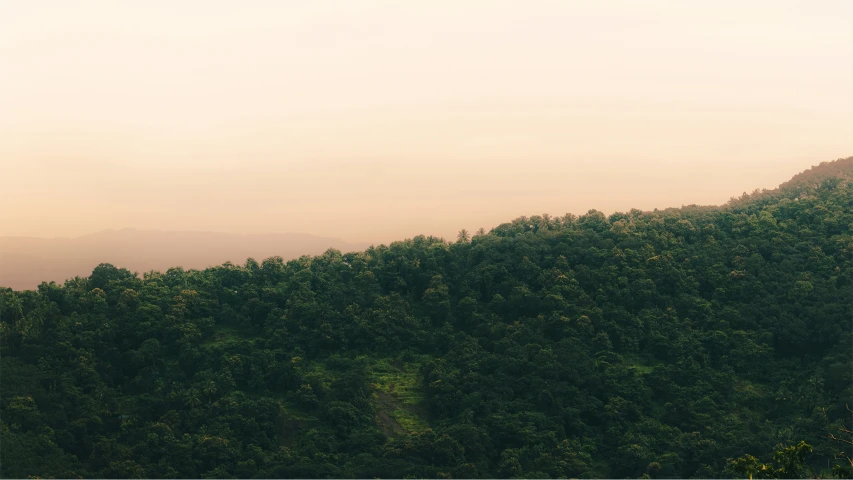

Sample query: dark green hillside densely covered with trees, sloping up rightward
[0,158,853,478]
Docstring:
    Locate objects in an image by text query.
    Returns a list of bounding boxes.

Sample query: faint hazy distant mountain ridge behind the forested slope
[0,229,367,290]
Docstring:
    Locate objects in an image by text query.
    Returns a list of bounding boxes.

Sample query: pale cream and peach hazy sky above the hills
[0,0,853,242]
